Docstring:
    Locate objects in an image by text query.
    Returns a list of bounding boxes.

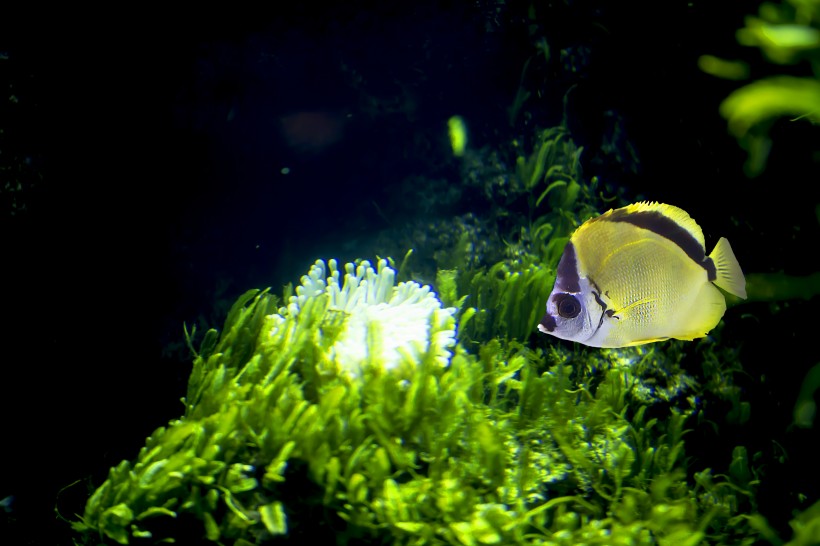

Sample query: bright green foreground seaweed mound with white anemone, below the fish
[74,249,772,545]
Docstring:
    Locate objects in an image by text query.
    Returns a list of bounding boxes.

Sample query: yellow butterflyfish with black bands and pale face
[538,202,746,347]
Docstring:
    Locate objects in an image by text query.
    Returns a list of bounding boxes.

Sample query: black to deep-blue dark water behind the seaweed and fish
[0,1,820,544]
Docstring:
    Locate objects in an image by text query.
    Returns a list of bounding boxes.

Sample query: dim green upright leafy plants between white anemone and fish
[435,127,619,341]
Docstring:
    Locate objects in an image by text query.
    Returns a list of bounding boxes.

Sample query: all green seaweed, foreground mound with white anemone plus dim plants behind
[73,42,818,546]
